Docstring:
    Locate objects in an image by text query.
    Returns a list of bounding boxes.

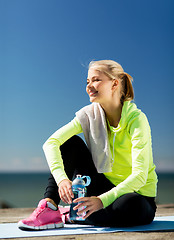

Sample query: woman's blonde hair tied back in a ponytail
[88,60,134,103]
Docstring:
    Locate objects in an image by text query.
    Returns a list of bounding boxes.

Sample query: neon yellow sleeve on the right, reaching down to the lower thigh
[99,113,152,207]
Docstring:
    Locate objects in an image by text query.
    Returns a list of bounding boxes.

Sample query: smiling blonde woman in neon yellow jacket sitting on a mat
[18,60,157,229]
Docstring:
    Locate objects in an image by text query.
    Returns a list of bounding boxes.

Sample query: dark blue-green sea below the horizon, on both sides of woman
[0,172,174,208]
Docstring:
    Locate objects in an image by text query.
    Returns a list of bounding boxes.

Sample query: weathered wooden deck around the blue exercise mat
[0,204,174,240]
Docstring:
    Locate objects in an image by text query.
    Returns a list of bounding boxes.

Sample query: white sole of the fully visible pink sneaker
[18,221,64,230]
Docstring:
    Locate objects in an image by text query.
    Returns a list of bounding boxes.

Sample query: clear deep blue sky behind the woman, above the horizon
[0,0,174,172]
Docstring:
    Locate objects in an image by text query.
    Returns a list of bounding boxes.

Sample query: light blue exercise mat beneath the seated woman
[0,216,174,238]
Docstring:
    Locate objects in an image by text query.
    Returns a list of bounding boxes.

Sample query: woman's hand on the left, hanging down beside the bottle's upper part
[58,179,74,204]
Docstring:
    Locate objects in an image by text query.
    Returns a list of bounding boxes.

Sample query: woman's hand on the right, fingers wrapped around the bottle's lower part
[73,197,103,219]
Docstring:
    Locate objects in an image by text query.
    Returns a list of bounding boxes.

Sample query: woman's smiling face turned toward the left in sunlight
[86,67,114,104]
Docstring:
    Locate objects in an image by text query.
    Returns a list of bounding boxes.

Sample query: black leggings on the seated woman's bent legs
[44,136,156,227]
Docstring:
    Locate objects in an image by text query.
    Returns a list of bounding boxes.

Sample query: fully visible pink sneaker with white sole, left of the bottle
[18,199,64,230]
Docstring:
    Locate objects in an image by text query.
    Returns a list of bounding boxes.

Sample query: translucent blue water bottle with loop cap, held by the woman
[70,175,91,221]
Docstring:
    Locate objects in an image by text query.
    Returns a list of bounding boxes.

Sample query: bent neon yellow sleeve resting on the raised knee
[43,117,82,185]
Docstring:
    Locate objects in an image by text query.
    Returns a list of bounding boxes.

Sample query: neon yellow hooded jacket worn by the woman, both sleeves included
[43,101,157,207]
